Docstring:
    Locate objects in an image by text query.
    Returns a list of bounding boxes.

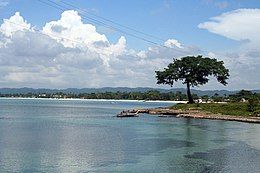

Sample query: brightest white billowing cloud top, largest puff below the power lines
[43,10,126,66]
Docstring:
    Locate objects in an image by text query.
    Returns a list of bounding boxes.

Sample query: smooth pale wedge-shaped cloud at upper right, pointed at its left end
[198,9,260,47]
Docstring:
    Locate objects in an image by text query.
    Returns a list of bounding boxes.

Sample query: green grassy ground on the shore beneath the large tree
[171,103,260,116]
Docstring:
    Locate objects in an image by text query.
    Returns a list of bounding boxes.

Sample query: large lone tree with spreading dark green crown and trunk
[155,55,229,103]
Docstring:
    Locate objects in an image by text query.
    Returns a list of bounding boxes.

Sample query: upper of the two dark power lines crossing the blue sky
[59,1,165,41]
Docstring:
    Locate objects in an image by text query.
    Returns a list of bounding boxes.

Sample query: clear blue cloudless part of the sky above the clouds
[0,0,260,51]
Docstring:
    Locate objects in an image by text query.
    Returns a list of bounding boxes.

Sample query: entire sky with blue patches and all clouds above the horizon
[0,0,260,90]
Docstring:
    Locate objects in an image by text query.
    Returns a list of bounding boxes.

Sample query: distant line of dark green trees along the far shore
[0,90,260,102]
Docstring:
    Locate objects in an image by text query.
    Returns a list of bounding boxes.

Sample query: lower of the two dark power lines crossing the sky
[38,0,165,48]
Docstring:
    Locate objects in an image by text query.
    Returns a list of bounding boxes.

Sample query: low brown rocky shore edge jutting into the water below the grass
[117,108,260,124]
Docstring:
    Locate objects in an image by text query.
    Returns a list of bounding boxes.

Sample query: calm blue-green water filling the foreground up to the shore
[0,99,260,173]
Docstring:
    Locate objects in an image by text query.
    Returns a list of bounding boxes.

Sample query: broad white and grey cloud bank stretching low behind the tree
[0,11,260,88]
